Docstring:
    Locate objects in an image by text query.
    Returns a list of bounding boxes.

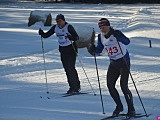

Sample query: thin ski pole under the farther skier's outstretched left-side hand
[41,36,49,94]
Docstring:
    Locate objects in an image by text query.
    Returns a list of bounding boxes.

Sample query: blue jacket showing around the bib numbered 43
[95,28,130,64]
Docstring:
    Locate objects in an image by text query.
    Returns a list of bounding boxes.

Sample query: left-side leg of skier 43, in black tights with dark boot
[107,64,123,116]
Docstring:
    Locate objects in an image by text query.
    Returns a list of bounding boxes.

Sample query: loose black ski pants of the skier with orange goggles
[60,45,80,90]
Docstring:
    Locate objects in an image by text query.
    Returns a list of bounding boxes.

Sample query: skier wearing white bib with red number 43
[89,18,135,117]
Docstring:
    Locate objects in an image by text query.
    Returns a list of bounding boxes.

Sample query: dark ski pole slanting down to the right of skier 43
[117,40,148,117]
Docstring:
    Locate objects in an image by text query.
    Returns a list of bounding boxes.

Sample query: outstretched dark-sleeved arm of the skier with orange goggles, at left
[39,25,56,38]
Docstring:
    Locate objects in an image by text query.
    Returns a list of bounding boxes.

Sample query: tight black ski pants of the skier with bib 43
[107,63,134,111]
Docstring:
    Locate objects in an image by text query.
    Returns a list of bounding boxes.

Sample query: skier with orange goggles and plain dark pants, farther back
[39,14,80,94]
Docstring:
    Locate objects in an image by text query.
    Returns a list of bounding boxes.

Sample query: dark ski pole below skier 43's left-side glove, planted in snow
[94,53,105,114]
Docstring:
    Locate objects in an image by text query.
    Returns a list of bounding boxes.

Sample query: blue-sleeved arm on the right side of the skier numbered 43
[114,30,130,45]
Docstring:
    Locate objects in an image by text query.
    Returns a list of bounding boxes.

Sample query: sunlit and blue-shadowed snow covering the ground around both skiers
[0,2,160,120]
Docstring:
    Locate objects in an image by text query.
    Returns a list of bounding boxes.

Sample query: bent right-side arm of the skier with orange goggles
[67,25,79,41]
